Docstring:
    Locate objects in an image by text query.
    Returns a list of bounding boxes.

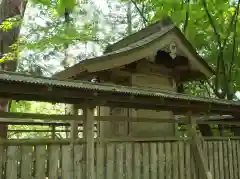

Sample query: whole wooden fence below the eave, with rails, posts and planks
[0,109,240,179]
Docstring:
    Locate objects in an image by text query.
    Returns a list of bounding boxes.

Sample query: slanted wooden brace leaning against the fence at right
[187,111,212,179]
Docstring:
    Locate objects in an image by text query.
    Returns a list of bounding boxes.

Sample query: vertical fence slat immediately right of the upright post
[96,142,105,179]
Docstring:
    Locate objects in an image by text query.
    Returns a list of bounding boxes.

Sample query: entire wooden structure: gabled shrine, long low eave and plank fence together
[0,16,240,179]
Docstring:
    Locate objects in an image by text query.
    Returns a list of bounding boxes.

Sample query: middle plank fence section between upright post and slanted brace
[96,142,194,179]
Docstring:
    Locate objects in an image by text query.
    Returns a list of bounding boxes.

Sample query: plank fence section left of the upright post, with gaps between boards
[0,145,85,179]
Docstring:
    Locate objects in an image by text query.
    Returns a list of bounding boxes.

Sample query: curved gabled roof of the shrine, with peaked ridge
[55,18,213,78]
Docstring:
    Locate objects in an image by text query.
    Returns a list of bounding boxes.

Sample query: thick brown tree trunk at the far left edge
[0,0,26,138]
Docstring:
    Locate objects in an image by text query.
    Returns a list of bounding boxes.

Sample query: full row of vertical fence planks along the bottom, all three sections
[0,140,240,179]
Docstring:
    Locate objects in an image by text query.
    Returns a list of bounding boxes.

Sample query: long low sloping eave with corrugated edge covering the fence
[0,72,240,116]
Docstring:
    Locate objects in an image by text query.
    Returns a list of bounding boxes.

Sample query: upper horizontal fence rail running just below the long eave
[0,112,240,126]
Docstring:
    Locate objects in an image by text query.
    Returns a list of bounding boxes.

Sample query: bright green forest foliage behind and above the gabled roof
[0,0,240,97]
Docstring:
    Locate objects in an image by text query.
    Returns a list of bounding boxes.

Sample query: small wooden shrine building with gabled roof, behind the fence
[56,18,213,137]
